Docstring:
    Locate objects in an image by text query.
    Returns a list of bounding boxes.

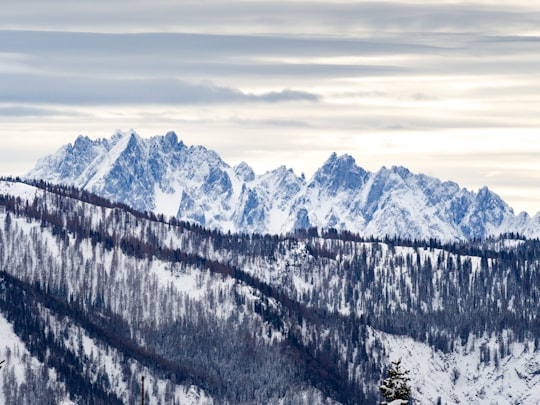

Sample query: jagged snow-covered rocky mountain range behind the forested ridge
[27,131,540,241]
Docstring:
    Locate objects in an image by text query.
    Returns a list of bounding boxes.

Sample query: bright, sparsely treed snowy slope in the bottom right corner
[376,331,540,405]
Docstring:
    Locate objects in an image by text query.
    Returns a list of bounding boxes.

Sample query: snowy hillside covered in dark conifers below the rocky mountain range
[0,179,540,404]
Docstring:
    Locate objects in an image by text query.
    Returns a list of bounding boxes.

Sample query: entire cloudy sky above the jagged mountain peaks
[0,0,540,214]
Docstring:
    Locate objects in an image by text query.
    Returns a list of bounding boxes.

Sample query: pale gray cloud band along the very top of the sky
[0,0,540,35]
